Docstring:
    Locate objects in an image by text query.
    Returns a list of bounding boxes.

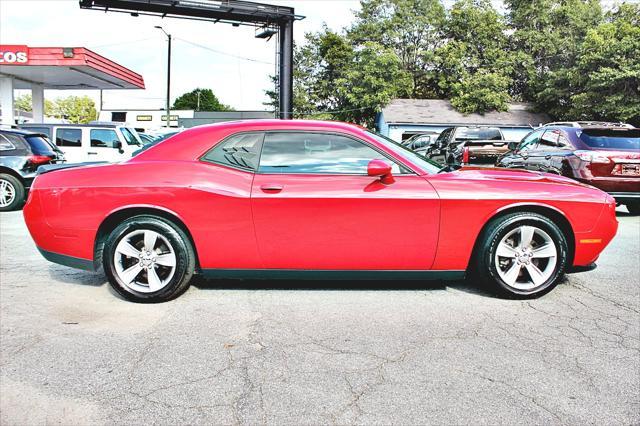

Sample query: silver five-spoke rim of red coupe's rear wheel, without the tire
[113,229,176,293]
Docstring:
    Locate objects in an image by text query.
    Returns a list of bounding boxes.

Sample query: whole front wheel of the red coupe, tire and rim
[476,213,567,298]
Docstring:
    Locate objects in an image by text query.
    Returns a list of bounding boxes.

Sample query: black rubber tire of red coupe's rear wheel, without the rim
[102,215,196,303]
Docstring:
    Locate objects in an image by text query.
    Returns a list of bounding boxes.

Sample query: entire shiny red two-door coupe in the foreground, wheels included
[24,120,617,302]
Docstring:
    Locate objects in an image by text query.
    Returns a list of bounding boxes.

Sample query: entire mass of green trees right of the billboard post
[268,0,640,125]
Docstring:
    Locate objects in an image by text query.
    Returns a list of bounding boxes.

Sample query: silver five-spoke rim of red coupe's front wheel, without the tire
[495,225,558,290]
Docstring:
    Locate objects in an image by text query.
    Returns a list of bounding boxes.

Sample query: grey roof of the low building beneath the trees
[382,99,550,127]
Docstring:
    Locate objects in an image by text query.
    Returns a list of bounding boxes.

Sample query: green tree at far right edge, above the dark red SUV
[559,4,640,126]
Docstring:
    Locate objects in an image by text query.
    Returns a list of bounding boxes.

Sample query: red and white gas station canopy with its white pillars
[0,45,144,124]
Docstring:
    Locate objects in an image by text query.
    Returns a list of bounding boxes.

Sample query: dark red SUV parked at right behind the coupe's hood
[496,126,640,214]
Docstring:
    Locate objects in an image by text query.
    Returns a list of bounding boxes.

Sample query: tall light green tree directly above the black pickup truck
[436,0,513,114]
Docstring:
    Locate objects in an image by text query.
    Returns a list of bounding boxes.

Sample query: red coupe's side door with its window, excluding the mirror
[251,132,440,270]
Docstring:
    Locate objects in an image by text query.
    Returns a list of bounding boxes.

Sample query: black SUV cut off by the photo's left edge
[0,129,64,211]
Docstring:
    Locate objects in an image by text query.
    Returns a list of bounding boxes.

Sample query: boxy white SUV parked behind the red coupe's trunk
[20,123,142,163]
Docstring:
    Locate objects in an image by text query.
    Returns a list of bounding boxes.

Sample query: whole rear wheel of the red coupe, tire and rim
[102,215,195,303]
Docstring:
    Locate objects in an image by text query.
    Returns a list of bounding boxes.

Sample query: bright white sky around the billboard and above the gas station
[0,0,359,110]
